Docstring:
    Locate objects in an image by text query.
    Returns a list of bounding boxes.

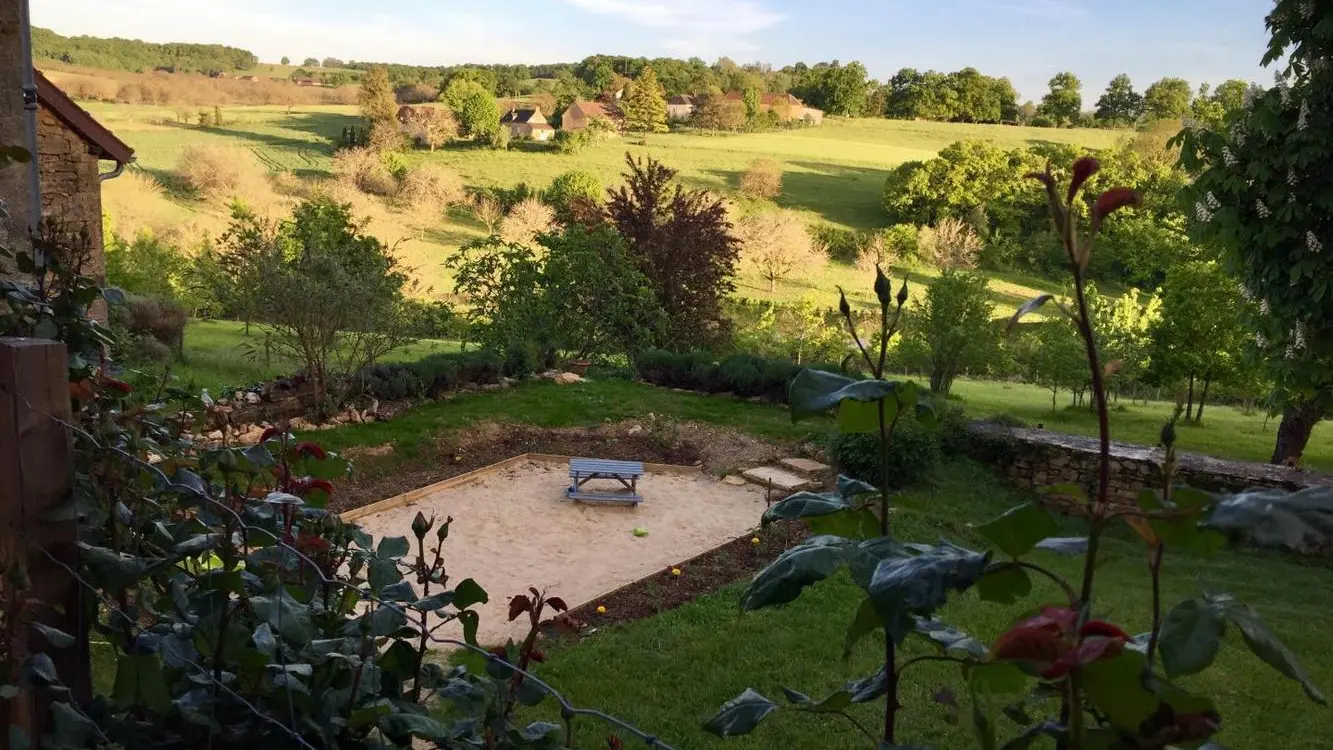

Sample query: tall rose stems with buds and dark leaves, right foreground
[704,159,1333,749]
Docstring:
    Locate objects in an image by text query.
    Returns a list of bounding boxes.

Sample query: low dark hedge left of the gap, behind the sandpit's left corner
[357,350,504,401]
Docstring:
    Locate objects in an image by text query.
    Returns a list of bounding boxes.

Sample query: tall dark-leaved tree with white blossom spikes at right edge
[1181,0,1333,464]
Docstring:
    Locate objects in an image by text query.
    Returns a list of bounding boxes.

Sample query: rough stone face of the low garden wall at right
[969,422,1333,504]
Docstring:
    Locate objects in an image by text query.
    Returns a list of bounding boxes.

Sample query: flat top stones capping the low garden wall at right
[972,421,1333,489]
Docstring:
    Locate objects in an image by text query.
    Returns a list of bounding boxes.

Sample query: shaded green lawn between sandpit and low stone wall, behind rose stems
[495,461,1333,750]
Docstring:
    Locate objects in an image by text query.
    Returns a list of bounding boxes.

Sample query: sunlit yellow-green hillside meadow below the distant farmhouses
[87,103,1122,313]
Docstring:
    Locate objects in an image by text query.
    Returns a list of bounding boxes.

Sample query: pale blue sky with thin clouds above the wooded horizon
[29,0,1272,100]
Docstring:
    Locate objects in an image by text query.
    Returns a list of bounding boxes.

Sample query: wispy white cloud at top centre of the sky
[564,0,785,57]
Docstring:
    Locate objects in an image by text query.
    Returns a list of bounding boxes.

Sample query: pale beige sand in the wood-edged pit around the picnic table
[356,461,765,645]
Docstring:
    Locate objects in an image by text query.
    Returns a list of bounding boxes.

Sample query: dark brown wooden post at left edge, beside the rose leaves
[0,338,92,747]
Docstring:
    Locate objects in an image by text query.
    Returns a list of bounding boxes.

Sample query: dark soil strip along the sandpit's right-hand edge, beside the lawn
[548,521,809,638]
